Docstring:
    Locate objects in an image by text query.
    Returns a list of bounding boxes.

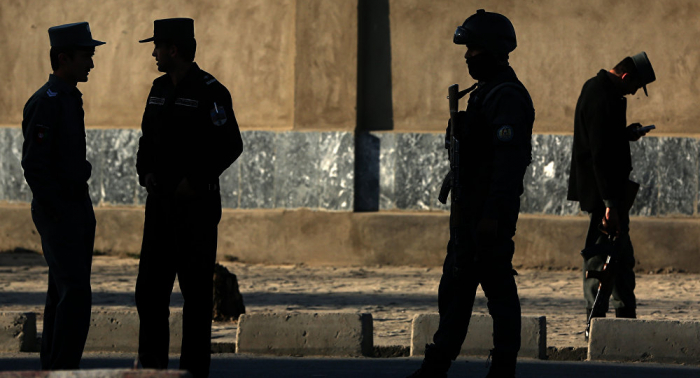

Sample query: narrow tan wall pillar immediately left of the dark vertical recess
[296,0,357,130]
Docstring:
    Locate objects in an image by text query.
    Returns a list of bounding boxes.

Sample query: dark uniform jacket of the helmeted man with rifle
[448,67,535,220]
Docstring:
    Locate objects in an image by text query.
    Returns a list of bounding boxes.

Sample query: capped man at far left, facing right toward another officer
[22,22,104,370]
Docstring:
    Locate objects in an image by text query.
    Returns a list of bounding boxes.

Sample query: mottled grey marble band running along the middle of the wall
[6,127,700,218]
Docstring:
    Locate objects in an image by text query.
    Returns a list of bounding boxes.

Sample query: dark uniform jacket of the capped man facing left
[136,63,243,194]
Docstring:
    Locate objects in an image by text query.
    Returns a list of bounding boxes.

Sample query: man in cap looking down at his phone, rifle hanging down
[567,52,656,324]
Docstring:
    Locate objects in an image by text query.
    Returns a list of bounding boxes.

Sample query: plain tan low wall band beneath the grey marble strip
[5,203,700,273]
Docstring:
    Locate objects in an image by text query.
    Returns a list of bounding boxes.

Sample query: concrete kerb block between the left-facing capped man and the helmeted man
[236,313,373,357]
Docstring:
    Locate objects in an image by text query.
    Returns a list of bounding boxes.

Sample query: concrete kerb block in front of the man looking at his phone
[588,318,700,364]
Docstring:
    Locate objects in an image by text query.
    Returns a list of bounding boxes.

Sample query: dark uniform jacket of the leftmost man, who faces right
[22,75,92,205]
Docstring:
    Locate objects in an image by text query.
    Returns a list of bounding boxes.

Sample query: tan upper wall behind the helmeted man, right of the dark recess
[390,0,700,135]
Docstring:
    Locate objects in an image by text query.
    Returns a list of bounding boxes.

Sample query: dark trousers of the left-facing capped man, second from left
[136,192,221,378]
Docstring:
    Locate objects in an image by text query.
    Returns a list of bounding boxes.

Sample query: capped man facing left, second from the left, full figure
[136,18,243,377]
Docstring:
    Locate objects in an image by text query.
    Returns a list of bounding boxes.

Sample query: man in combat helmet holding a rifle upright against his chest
[411,9,535,377]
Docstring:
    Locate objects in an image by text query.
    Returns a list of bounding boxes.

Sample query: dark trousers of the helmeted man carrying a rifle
[431,204,521,361]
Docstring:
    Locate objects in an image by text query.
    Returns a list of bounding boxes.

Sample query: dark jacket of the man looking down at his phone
[567,70,632,212]
